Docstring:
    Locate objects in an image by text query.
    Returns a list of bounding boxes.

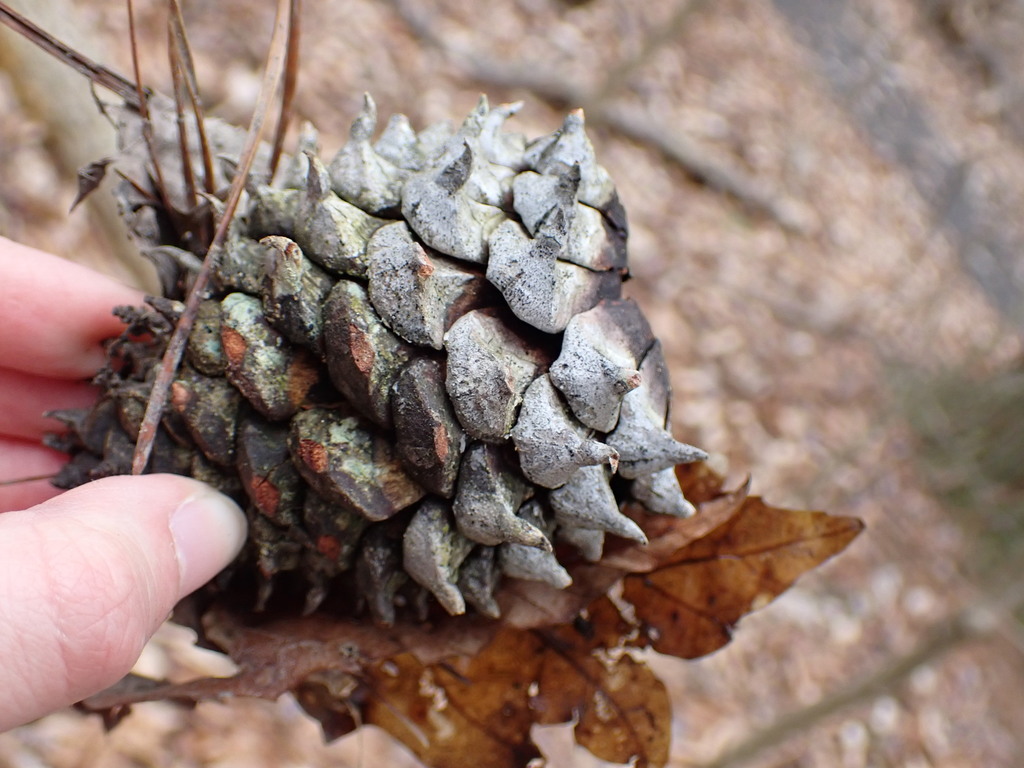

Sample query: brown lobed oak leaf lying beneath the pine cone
[83,465,862,768]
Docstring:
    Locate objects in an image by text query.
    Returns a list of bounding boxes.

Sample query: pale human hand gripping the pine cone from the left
[0,238,246,731]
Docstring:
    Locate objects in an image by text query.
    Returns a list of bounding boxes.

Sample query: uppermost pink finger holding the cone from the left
[0,238,142,379]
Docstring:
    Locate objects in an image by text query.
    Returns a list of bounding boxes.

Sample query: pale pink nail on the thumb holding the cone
[170,489,247,597]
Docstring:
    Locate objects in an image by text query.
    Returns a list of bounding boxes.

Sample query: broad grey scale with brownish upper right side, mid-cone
[444,310,546,442]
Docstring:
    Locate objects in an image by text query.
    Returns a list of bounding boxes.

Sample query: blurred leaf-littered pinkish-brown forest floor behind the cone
[0,0,1024,768]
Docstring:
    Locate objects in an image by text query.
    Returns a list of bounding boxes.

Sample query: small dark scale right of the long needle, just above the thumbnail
[171,368,242,467]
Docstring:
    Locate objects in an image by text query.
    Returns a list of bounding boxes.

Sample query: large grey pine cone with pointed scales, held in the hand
[51,96,706,623]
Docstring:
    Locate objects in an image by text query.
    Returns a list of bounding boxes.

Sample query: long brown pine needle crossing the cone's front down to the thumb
[131,0,292,475]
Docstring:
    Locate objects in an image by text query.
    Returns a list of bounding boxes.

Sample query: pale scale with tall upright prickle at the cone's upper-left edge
[330,93,409,214]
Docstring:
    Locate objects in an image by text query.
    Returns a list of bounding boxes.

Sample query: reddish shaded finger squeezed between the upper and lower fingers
[0,368,98,440]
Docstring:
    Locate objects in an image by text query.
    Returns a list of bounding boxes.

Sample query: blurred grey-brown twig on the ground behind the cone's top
[391,0,813,233]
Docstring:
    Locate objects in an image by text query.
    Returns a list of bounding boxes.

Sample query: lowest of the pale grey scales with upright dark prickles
[487,221,622,334]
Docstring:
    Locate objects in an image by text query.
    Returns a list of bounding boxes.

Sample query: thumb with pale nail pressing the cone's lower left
[0,475,246,731]
